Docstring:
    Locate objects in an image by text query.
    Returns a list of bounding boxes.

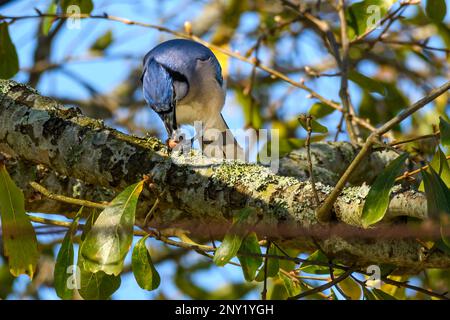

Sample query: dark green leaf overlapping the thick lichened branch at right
[361,153,408,227]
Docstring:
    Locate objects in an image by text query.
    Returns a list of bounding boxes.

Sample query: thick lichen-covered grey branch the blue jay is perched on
[0,80,450,273]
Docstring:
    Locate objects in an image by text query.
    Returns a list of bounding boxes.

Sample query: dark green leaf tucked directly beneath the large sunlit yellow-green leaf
[78,255,121,300]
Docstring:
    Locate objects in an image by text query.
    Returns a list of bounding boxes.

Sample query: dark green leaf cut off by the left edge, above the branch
[0,22,19,79]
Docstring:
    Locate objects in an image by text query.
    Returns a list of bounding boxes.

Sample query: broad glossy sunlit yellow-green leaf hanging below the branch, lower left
[80,181,143,276]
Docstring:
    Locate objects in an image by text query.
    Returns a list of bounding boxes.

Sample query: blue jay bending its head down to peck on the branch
[141,39,243,159]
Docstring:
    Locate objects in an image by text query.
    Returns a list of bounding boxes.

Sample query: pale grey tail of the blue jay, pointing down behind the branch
[202,115,246,161]
